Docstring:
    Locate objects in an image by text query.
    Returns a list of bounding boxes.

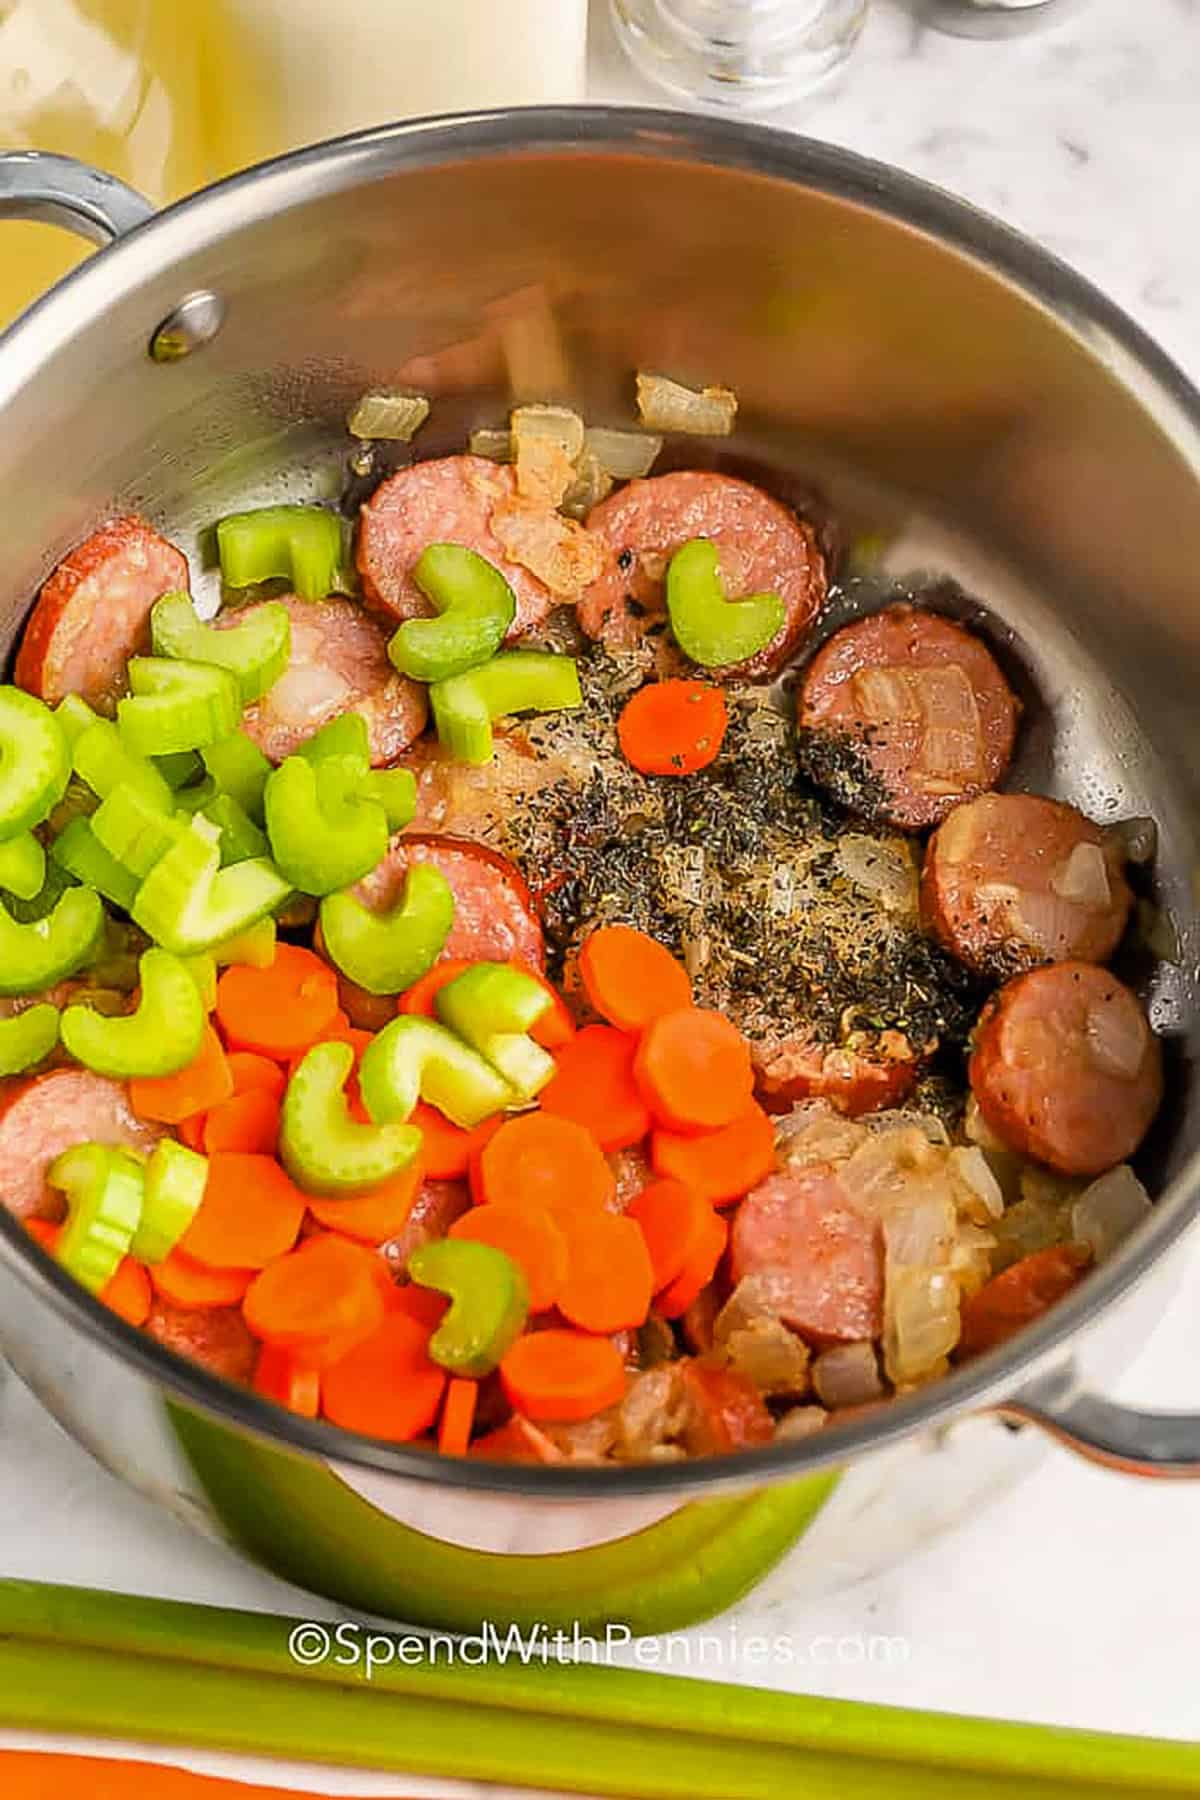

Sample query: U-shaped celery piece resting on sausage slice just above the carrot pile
[320,862,453,994]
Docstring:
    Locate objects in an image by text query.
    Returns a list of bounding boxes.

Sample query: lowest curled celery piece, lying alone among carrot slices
[408,1238,529,1381]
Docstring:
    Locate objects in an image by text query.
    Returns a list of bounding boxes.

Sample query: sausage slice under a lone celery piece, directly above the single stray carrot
[578,470,826,679]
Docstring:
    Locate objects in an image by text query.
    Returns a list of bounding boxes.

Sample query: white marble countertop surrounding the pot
[0,0,1200,1796]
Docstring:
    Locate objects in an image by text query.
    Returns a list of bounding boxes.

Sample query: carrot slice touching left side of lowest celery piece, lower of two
[320,1312,446,1444]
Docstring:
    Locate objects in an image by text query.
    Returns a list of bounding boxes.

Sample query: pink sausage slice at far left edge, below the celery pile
[0,1067,162,1219]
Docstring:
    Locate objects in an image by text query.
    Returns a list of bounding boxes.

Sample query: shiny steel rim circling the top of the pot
[0,106,1200,1501]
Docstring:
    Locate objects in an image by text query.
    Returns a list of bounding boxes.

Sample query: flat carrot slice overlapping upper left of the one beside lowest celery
[243,1233,387,1359]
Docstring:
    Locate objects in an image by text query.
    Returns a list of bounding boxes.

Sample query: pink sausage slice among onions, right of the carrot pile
[729,1163,883,1345]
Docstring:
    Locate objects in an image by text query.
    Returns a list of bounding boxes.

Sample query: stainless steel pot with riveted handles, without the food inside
[0,108,1200,1631]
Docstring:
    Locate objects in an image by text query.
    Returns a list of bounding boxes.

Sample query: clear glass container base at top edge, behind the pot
[610,0,867,112]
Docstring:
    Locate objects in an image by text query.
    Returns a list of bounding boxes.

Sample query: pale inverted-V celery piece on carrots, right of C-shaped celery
[358,1013,516,1130]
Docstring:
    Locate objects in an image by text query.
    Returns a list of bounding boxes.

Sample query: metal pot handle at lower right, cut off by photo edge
[997,1368,1200,1480]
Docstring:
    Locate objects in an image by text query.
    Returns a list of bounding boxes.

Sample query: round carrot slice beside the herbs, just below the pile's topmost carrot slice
[633,1006,754,1132]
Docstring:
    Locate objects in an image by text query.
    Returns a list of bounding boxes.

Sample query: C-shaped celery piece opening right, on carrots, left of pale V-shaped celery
[279,1042,421,1197]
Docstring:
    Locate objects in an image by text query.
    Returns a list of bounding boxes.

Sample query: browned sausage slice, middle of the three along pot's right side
[921,794,1132,979]
